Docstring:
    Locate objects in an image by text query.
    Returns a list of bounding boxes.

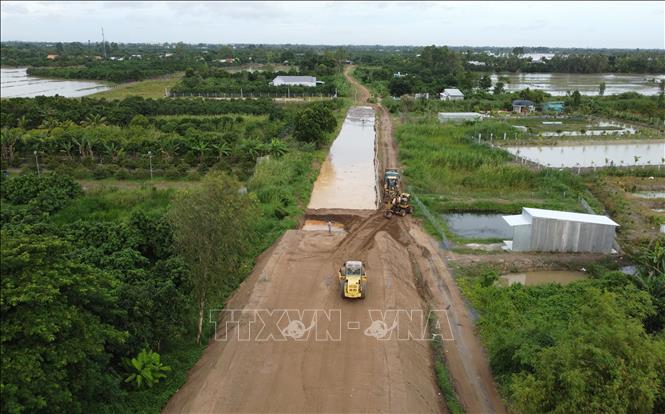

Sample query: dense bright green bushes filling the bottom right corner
[457,239,665,414]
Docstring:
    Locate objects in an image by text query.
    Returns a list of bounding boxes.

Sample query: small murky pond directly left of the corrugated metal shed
[443,213,513,239]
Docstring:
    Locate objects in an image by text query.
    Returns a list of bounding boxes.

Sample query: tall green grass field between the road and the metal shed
[396,118,602,243]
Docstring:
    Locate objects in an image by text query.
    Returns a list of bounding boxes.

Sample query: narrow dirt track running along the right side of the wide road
[344,67,506,414]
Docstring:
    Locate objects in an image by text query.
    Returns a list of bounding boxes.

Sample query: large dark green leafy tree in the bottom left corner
[0,230,126,413]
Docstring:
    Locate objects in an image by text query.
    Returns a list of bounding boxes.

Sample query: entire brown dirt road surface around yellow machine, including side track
[163,65,505,413]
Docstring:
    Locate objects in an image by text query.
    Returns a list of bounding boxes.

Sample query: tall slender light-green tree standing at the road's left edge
[168,173,259,343]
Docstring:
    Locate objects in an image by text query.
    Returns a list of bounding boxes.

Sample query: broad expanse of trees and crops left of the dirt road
[0,64,348,413]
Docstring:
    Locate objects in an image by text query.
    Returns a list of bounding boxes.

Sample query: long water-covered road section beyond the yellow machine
[307,106,377,210]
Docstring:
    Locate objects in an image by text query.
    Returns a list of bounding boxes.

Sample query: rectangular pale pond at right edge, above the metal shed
[504,141,665,168]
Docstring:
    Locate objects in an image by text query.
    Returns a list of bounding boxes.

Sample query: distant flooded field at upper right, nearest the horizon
[492,73,665,96]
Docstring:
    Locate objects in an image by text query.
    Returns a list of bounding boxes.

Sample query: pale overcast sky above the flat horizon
[0,1,665,49]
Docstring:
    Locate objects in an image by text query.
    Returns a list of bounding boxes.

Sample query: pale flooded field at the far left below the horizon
[0,68,111,98]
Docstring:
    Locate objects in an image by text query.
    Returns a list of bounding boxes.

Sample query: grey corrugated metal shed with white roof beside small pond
[503,207,619,253]
